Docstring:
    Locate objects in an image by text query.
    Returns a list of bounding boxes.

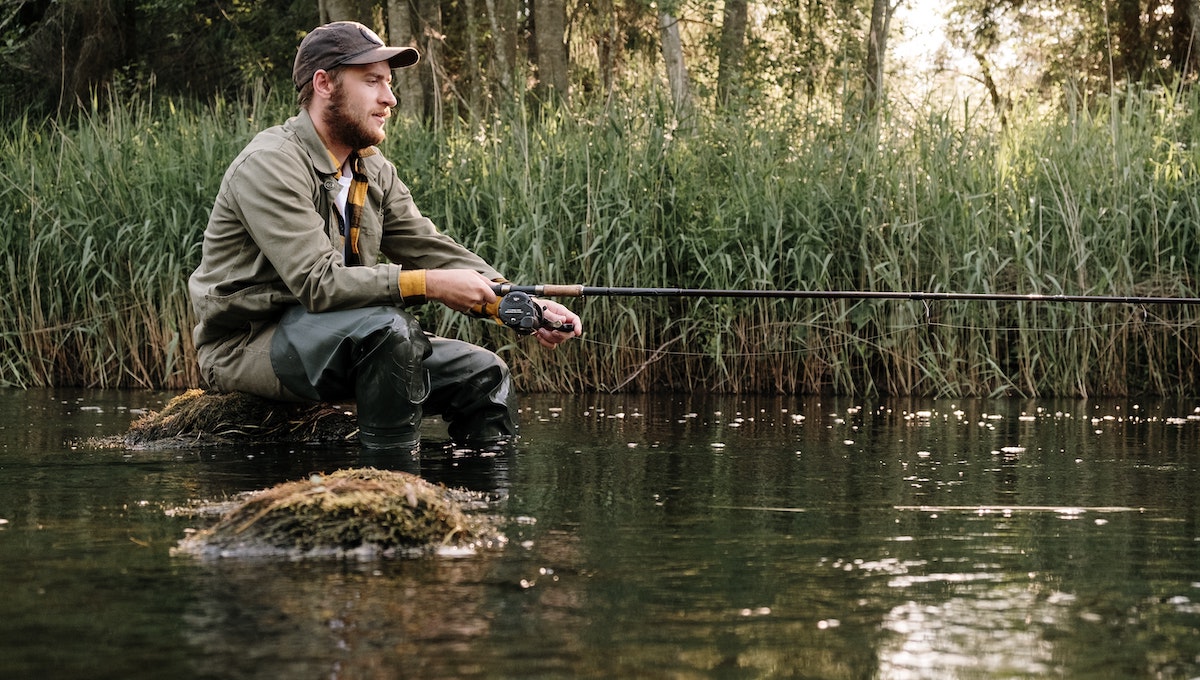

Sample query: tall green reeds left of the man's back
[0,91,270,387]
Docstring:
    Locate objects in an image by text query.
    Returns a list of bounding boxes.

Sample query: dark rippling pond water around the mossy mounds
[0,390,1200,679]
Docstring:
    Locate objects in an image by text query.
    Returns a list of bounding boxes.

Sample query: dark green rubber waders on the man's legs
[271,306,516,452]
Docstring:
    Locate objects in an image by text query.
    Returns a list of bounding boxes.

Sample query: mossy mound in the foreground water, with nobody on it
[178,468,503,556]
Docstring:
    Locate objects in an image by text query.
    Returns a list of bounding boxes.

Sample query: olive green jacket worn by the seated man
[188,110,500,396]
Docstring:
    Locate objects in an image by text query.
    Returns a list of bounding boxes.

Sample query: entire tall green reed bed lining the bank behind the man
[0,85,1200,396]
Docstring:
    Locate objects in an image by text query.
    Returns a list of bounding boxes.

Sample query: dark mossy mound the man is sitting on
[104,390,358,449]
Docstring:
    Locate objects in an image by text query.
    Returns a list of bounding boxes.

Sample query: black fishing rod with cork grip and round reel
[492,283,1200,335]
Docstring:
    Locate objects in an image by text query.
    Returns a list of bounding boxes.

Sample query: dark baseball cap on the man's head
[292,22,421,90]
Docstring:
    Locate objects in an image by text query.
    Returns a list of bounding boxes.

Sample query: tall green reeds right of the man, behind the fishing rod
[410,85,1200,396]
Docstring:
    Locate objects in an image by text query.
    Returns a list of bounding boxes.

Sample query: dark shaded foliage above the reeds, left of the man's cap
[0,0,317,115]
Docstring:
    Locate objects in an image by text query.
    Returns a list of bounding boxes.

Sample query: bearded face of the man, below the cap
[325,61,396,149]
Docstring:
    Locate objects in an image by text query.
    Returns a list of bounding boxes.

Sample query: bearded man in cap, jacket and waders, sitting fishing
[188,22,582,452]
